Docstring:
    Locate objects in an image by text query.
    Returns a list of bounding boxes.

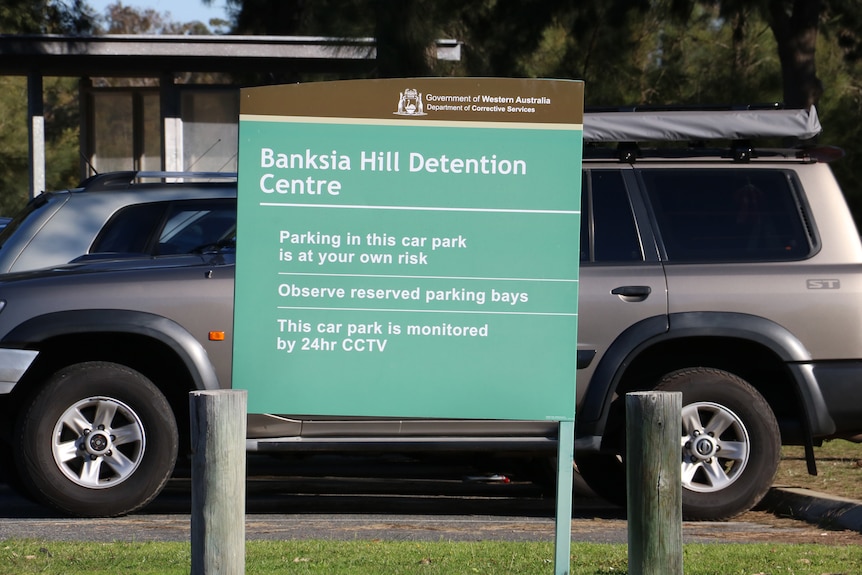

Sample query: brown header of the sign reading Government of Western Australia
[240,78,584,124]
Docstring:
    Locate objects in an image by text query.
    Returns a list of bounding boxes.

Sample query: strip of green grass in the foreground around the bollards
[0,540,862,575]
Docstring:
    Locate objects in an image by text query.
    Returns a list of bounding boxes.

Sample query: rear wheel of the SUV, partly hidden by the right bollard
[656,368,781,520]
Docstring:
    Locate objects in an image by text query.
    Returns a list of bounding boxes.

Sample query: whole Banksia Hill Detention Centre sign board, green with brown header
[233,78,583,421]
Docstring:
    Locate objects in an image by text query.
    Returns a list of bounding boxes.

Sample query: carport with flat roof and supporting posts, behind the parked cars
[0,34,460,200]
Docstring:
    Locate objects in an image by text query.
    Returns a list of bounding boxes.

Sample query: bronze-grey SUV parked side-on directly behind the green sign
[0,108,862,519]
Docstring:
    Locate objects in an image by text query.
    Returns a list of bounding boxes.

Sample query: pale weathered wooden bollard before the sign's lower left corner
[189,389,248,575]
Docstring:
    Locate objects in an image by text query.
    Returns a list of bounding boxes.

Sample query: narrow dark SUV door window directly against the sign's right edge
[581,170,643,263]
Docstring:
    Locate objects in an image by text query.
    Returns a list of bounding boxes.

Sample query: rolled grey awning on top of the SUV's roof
[584,105,821,144]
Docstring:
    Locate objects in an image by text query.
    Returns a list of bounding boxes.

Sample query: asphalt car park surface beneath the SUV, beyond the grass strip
[0,457,862,544]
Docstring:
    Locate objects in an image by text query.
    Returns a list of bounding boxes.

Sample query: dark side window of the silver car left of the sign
[90,200,236,256]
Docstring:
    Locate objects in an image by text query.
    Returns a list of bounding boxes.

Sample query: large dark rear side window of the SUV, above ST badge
[639,169,813,262]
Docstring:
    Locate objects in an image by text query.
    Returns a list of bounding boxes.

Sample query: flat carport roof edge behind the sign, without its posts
[0,34,460,77]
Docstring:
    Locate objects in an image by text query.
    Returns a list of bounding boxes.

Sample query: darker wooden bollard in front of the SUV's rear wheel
[626,391,683,575]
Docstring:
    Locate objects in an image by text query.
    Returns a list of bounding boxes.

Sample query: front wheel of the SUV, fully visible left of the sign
[15,362,178,517]
